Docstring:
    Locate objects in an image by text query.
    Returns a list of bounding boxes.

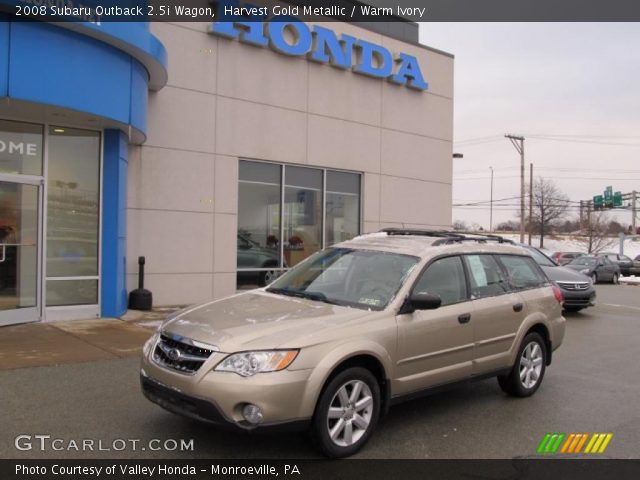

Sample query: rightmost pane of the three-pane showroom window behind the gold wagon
[325,171,360,246]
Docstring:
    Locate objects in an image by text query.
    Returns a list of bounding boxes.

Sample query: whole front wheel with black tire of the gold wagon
[312,367,381,458]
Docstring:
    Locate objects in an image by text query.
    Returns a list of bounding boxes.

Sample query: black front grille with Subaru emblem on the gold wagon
[153,333,216,375]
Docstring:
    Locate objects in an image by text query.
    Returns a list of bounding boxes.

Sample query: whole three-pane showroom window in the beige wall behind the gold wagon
[237,160,361,288]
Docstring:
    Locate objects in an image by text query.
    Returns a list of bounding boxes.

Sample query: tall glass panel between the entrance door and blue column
[46,127,100,306]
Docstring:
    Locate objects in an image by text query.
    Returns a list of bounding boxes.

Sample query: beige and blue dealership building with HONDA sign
[0,1,453,325]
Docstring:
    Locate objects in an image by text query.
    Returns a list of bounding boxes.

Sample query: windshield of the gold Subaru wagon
[267,248,420,310]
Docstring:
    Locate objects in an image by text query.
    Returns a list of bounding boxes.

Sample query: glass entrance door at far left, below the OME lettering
[0,174,41,326]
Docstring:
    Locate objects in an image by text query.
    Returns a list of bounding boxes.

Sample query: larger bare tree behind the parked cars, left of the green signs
[531,177,569,248]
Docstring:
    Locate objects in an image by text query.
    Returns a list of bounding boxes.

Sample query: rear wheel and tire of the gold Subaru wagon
[498,332,547,397]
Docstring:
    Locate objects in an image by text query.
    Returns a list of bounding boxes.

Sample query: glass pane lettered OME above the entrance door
[0,120,43,175]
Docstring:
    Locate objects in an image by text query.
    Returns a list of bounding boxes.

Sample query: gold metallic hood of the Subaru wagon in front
[162,290,372,353]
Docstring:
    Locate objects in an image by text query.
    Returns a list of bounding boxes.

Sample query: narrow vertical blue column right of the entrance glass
[101,130,129,317]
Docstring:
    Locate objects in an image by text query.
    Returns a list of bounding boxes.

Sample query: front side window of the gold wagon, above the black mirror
[413,257,467,305]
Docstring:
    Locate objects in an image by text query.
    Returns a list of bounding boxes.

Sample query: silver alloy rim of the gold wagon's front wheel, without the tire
[327,380,374,447]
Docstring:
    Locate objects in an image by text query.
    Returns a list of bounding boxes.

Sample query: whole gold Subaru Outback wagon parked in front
[141,229,565,457]
